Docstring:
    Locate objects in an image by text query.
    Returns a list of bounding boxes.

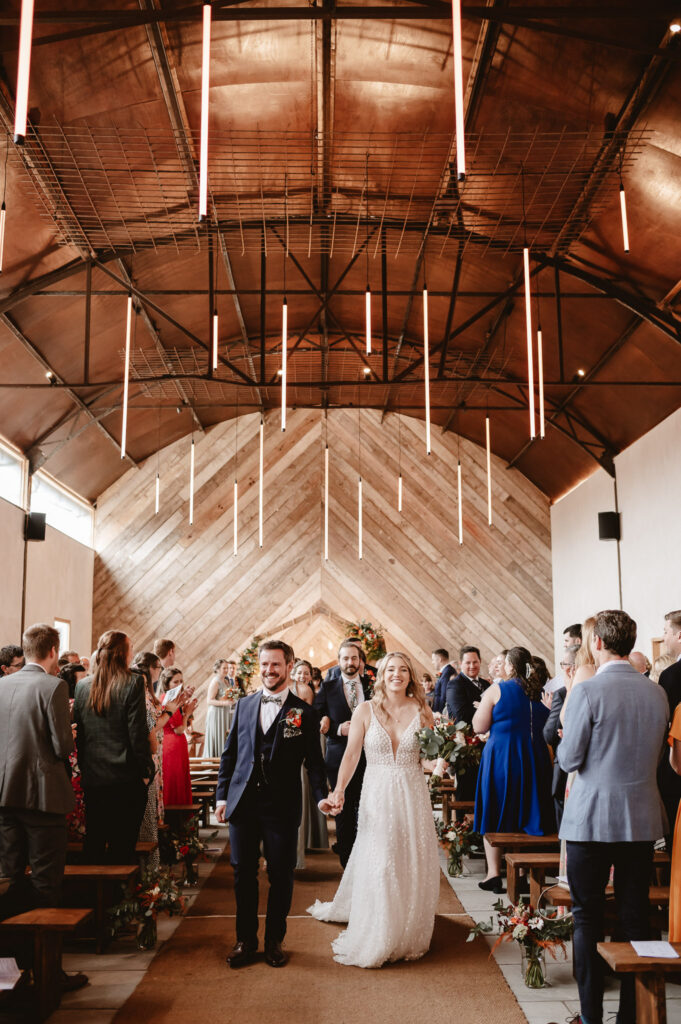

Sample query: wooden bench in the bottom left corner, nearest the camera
[0,907,92,1021]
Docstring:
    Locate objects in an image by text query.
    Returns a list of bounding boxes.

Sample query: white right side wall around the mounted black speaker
[551,410,681,657]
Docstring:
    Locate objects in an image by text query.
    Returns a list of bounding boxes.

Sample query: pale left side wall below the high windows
[0,499,94,654]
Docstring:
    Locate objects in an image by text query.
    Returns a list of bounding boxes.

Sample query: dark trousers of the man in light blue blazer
[567,841,653,1024]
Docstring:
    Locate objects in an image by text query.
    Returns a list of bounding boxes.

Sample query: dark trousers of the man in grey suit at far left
[0,807,68,920]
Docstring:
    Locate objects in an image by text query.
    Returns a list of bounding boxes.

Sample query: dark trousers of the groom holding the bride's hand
[229,783,299,946]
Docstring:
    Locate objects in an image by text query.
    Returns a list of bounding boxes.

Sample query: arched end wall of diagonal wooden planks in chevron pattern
[93,410,553,723]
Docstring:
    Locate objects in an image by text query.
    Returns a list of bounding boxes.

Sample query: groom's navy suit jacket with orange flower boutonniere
[216,691,329,822]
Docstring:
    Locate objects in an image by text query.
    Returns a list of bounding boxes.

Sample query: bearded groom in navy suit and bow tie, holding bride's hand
[216,640,332,968]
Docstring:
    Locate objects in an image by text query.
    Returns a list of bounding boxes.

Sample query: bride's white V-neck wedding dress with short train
[308,705,439,967]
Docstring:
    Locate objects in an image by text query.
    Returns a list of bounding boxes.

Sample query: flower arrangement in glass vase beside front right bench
[467,899,573,988]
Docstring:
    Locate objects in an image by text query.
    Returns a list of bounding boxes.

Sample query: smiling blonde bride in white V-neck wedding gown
[308,651,439,967]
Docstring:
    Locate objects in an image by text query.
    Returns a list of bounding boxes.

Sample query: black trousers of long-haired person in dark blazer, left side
[83,779,146,864]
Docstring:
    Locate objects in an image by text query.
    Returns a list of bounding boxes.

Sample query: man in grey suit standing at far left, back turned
[0,624,75,919]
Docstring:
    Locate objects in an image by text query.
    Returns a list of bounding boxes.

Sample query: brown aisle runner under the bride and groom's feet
[115,851,525,1024]
